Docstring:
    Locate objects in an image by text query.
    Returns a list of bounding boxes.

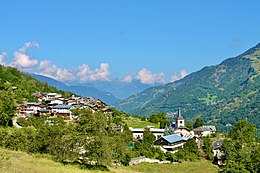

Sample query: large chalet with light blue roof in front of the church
[154,134,186,153]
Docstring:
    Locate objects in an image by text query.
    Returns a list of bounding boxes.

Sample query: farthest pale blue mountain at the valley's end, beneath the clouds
[66,79,159,100]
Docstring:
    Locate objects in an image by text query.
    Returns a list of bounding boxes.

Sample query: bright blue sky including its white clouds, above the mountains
[0,0,260,84]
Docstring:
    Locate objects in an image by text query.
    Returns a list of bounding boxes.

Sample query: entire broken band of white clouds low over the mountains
[0,42,187,84]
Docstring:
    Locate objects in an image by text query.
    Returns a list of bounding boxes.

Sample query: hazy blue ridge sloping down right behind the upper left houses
[30,74,121,105]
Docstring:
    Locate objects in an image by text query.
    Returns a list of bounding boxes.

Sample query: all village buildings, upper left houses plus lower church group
[15,92,223,165]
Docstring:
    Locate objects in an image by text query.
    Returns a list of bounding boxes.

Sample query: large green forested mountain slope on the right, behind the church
[116,44,260,130]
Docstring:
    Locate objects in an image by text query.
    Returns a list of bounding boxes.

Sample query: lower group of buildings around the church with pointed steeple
[129,111,223,164]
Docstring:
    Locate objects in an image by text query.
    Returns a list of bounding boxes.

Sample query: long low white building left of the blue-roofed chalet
[129,126,165,141]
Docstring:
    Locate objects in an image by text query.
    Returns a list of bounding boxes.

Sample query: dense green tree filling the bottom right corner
[221,120,260,173]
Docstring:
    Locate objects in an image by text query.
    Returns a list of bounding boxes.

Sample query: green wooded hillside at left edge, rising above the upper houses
[0,65,71,126]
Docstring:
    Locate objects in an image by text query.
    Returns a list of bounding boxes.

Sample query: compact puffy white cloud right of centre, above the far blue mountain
[136,68,165,84]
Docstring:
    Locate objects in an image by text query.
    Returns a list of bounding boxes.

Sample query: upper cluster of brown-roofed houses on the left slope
[17,92,111,119]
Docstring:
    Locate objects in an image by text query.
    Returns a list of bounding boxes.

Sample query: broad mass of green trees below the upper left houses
[0,109,138,168]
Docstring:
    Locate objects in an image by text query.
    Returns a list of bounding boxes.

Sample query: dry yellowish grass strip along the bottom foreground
[0,148,219,173]
